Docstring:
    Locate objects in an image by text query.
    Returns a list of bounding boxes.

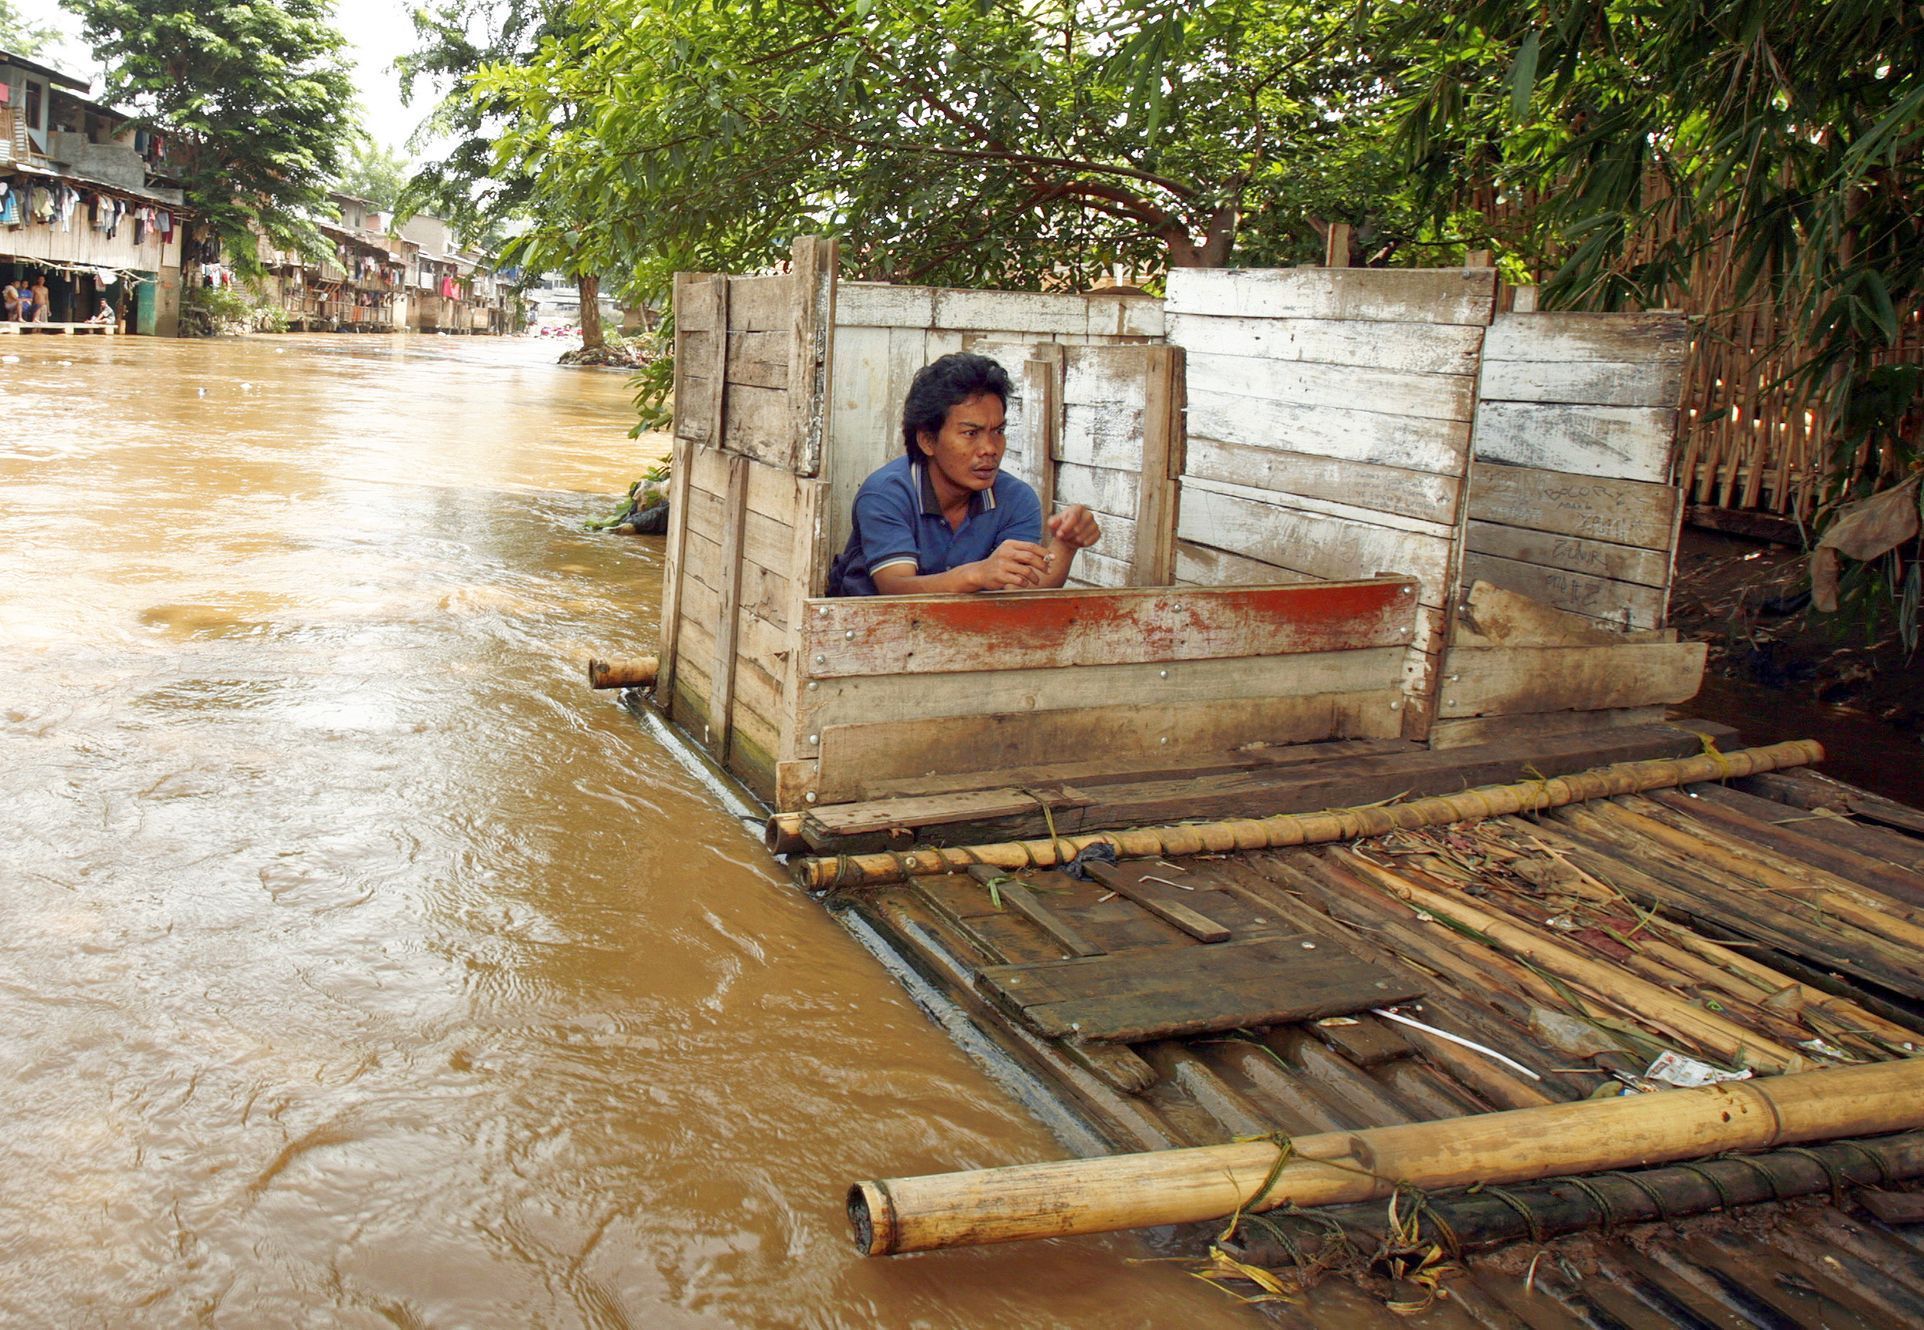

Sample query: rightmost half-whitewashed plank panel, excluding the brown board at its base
[1462,314,1689,629]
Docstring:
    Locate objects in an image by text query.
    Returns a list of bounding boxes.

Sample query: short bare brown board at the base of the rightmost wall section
[1437,643,1705,718]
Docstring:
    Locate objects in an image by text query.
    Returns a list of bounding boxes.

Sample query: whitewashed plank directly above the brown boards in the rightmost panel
[1476,402,1678,483]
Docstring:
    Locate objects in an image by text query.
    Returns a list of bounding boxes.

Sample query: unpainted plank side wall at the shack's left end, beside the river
[656,239,833,799]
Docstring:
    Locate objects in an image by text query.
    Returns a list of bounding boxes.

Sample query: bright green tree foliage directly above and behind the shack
[473,0,1395,293]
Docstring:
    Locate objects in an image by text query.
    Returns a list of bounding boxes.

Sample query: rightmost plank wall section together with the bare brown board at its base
[1430,312,1705,747]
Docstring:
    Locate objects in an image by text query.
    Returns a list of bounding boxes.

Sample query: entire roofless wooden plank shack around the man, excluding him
[656,241,1701,810]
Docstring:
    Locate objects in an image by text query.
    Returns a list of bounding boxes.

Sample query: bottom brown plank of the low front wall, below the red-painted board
[816,689,1401,803]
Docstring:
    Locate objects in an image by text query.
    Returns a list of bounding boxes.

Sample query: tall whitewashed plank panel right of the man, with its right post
[1166,268,1497,737]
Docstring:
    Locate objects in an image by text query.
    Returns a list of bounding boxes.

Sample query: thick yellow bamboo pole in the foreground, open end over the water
[848,1059,1924,1257]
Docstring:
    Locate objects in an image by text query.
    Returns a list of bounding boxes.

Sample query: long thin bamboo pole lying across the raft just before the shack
[795,739,1824,891]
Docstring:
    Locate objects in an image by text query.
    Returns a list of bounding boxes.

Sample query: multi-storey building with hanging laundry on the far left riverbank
[0,50,192,337]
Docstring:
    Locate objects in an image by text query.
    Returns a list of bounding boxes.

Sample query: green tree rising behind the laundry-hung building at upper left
[63,0,358,269]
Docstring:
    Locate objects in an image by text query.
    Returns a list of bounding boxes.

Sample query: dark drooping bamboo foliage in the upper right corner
[1391,0,1924,527]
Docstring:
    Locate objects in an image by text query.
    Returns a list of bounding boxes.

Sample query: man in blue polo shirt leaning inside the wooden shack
[829,354,1102,595]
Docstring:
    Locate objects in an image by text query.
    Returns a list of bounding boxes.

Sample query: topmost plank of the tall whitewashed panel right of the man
[1166,268,1497,323]
